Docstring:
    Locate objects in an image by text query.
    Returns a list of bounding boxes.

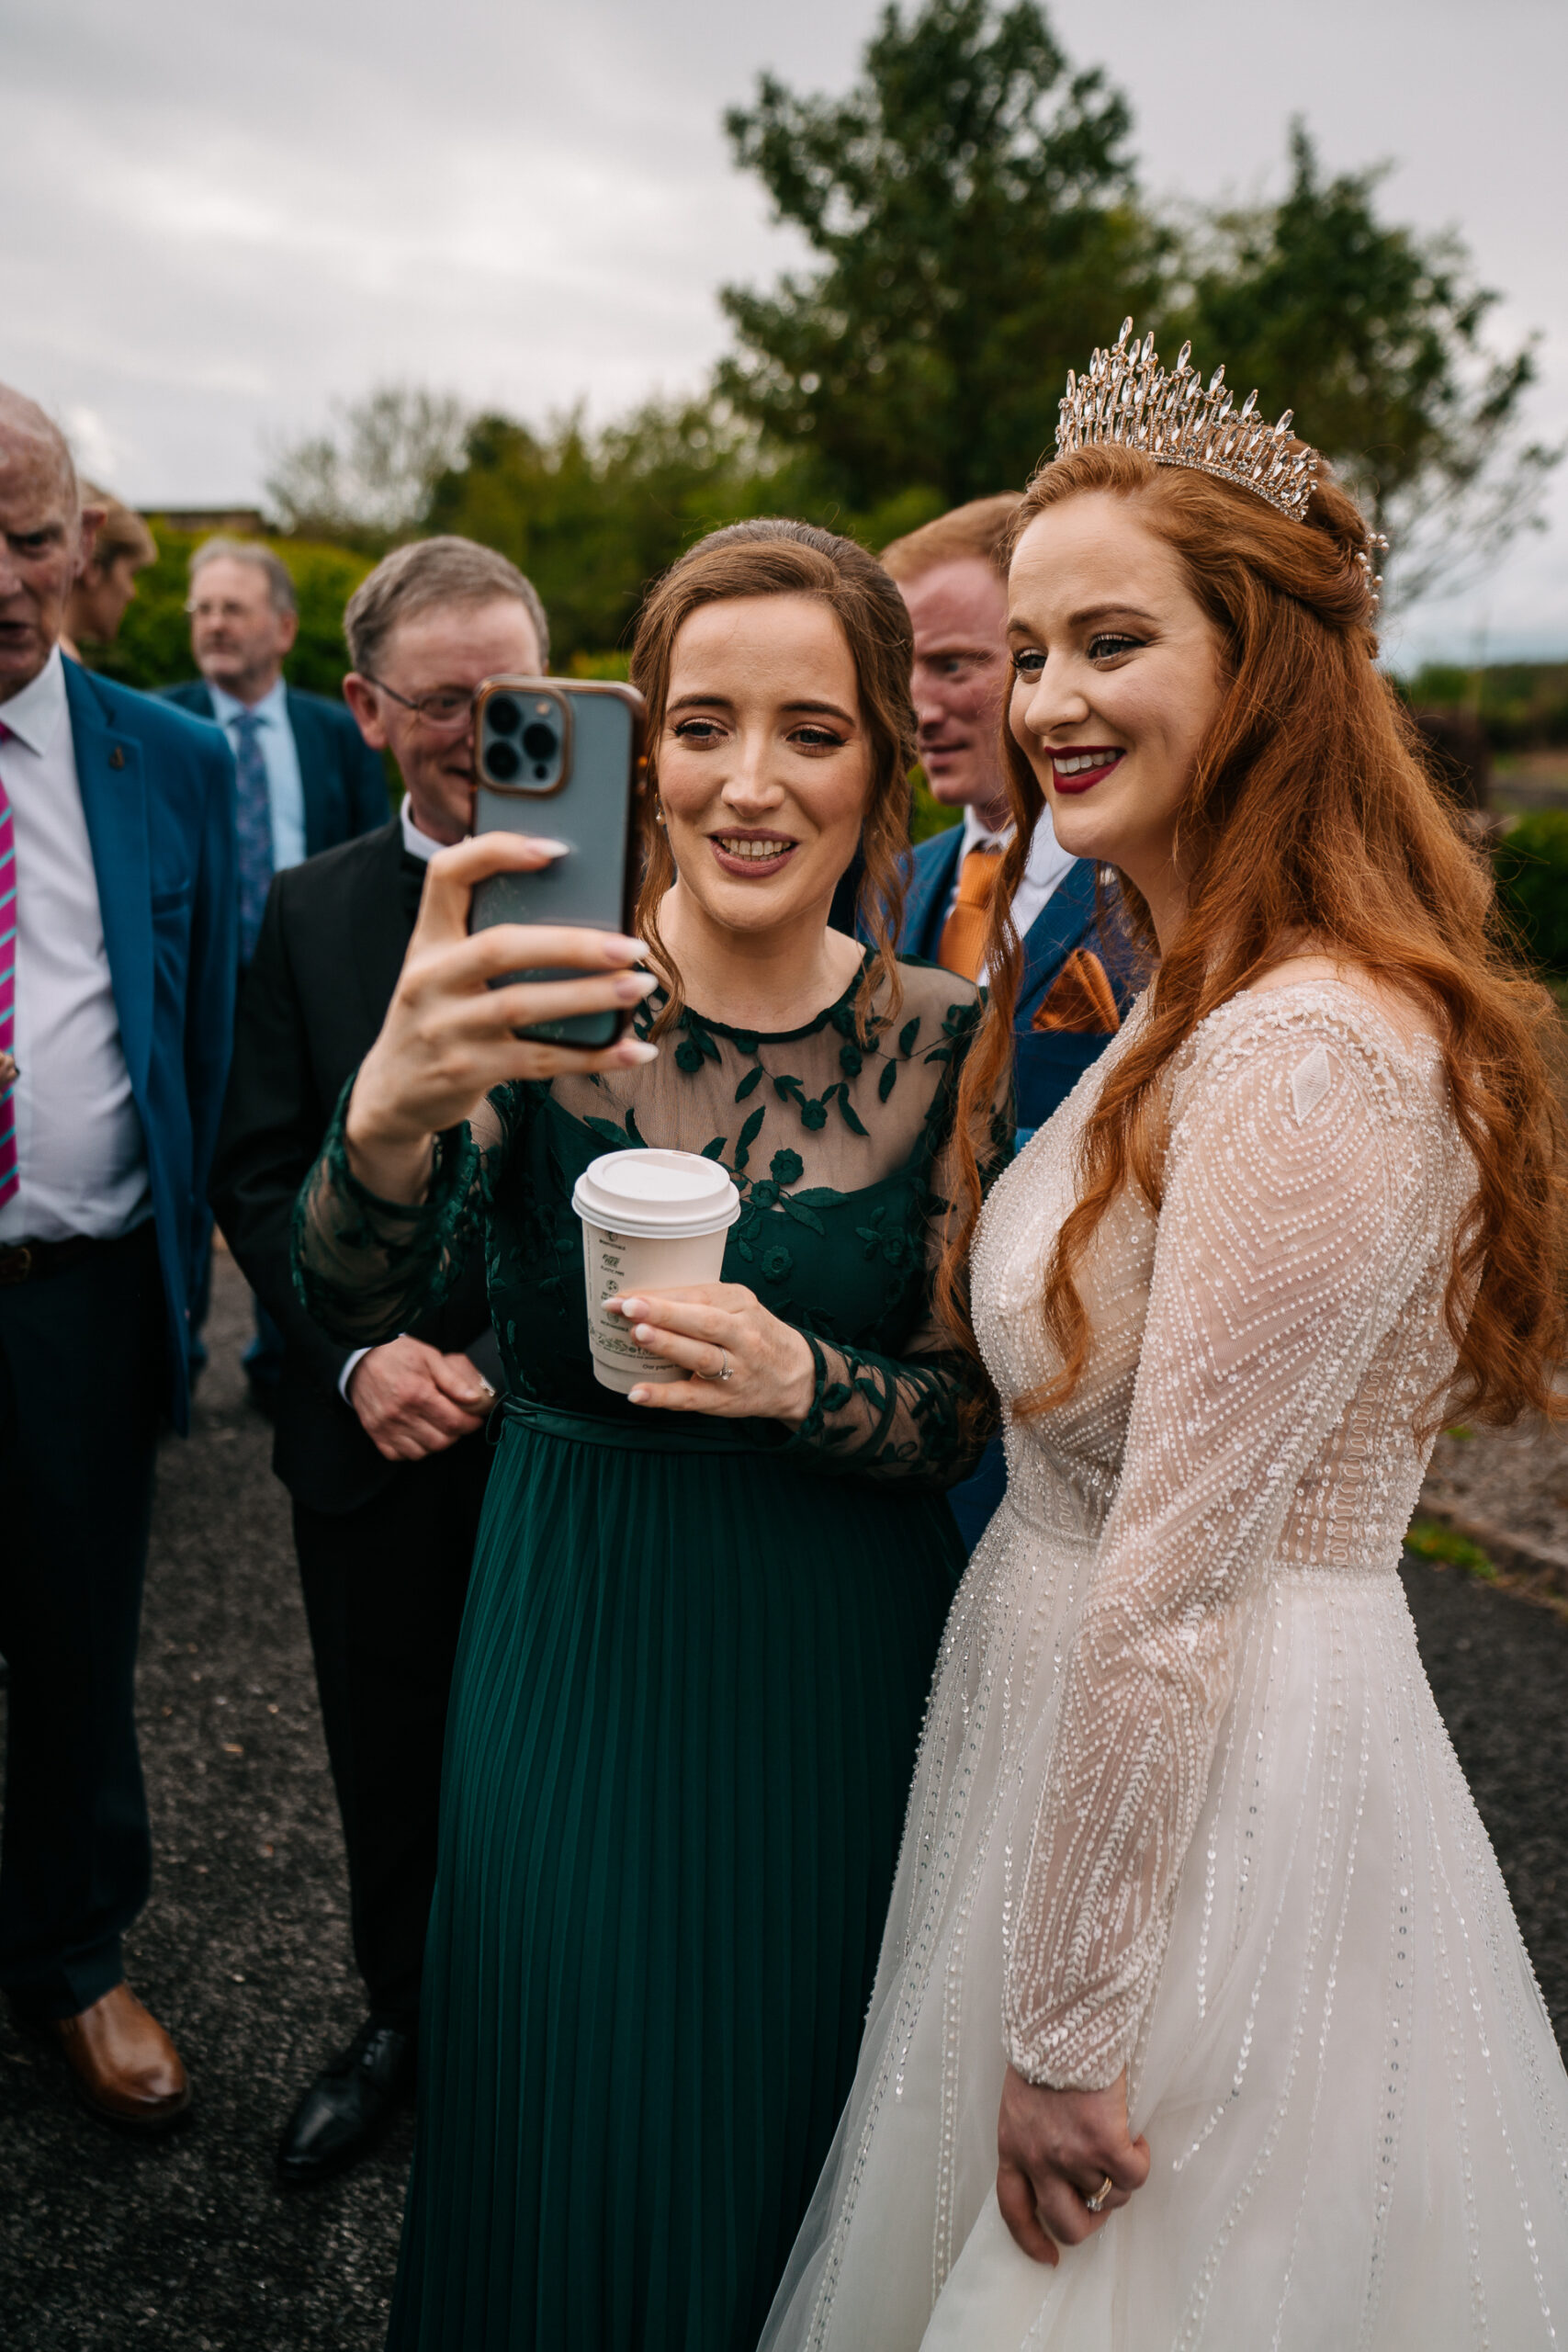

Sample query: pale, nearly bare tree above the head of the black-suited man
[265,383,468,555]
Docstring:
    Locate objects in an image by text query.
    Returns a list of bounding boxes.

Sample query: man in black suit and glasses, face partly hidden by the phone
[211,538,547,2188]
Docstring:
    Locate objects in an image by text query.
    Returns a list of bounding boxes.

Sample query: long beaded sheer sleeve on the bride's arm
[1004,986,1441,2088]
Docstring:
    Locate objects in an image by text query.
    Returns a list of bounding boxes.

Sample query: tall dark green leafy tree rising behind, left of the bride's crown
[719,0,1168,517]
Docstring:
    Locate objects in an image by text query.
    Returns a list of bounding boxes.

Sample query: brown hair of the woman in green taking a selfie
[632,520,915,1035]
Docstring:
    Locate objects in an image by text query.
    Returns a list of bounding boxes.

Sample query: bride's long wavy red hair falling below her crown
[941,447,1568,1428]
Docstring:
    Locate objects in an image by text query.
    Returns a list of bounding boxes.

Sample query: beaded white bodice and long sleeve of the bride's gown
[974,981,1474,2086]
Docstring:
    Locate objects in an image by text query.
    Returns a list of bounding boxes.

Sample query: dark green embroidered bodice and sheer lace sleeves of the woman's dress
[296,962,1010,1484]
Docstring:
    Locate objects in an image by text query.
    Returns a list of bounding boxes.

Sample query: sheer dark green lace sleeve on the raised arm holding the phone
[294,1072,525,1348]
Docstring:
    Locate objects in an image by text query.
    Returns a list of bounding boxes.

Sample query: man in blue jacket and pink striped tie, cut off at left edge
[0,388,235,2131]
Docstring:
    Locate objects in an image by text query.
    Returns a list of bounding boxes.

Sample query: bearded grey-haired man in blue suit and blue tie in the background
[164,538,388,1416]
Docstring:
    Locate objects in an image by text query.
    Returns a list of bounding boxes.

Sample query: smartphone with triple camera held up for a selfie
[468,677,644,1046]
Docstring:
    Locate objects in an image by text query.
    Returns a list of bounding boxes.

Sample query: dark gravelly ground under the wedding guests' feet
[0,1259,1568,2352]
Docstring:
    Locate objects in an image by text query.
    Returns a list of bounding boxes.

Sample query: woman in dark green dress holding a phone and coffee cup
[296,522,1009,2352]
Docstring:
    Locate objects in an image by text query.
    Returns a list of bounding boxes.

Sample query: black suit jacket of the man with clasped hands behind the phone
[211,823,493,1512]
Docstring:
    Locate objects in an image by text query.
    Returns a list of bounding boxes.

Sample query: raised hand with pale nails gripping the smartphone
[345,832,659,1202]
